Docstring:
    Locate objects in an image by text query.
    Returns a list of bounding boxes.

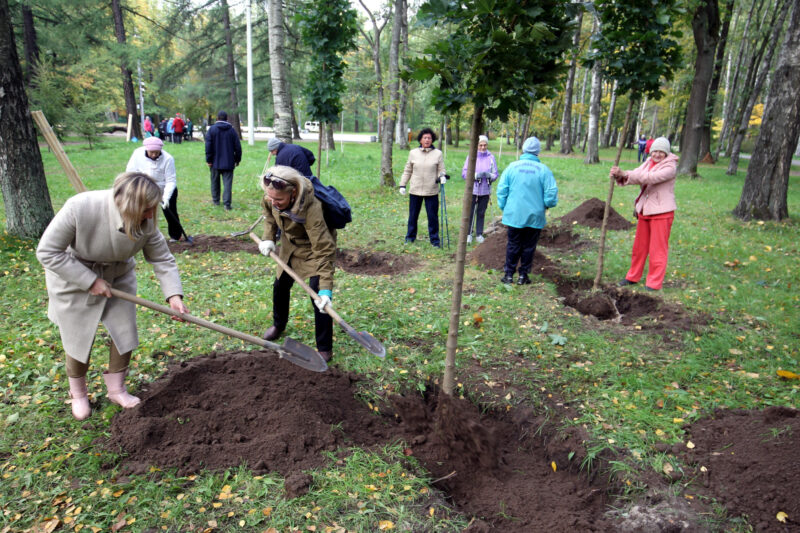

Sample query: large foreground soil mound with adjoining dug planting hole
[107,351,613,532]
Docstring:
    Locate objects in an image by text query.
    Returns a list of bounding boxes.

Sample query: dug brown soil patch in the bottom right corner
[673,407,800,532]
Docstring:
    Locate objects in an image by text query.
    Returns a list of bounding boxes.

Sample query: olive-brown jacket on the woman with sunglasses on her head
[261,178,336,291]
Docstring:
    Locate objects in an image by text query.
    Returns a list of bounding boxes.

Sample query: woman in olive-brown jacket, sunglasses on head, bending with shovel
[258,166,336,361]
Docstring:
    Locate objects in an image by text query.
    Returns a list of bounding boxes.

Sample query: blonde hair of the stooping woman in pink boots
[112,172,161,240]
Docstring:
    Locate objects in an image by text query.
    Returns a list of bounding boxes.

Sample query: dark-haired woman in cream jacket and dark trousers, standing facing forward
[400,128,447,248]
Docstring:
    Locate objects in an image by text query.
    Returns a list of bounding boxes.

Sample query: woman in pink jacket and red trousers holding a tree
[610,137,678,291]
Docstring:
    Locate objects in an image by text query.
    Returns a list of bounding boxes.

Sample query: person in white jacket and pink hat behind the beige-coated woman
[125,137,194,244]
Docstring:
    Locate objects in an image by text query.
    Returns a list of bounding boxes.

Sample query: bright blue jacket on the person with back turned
[497,153,558,229]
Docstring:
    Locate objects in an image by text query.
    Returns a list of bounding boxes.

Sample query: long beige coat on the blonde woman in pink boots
[36,190,183,363]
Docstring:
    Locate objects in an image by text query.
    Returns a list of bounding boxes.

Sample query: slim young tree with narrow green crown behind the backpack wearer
[297,0,358,176]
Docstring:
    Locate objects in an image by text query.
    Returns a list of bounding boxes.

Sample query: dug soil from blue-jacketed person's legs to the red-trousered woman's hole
[469,226,708,336]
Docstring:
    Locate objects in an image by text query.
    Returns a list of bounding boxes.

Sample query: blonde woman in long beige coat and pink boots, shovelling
[36,172,189,420]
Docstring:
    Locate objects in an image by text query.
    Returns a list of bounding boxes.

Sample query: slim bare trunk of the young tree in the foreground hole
[442,105,483,396]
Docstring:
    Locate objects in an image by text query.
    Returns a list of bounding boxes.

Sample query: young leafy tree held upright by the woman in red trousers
[587,0,680,289]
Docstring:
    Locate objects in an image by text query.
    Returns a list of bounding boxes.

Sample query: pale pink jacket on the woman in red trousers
[622,154,678,216]
